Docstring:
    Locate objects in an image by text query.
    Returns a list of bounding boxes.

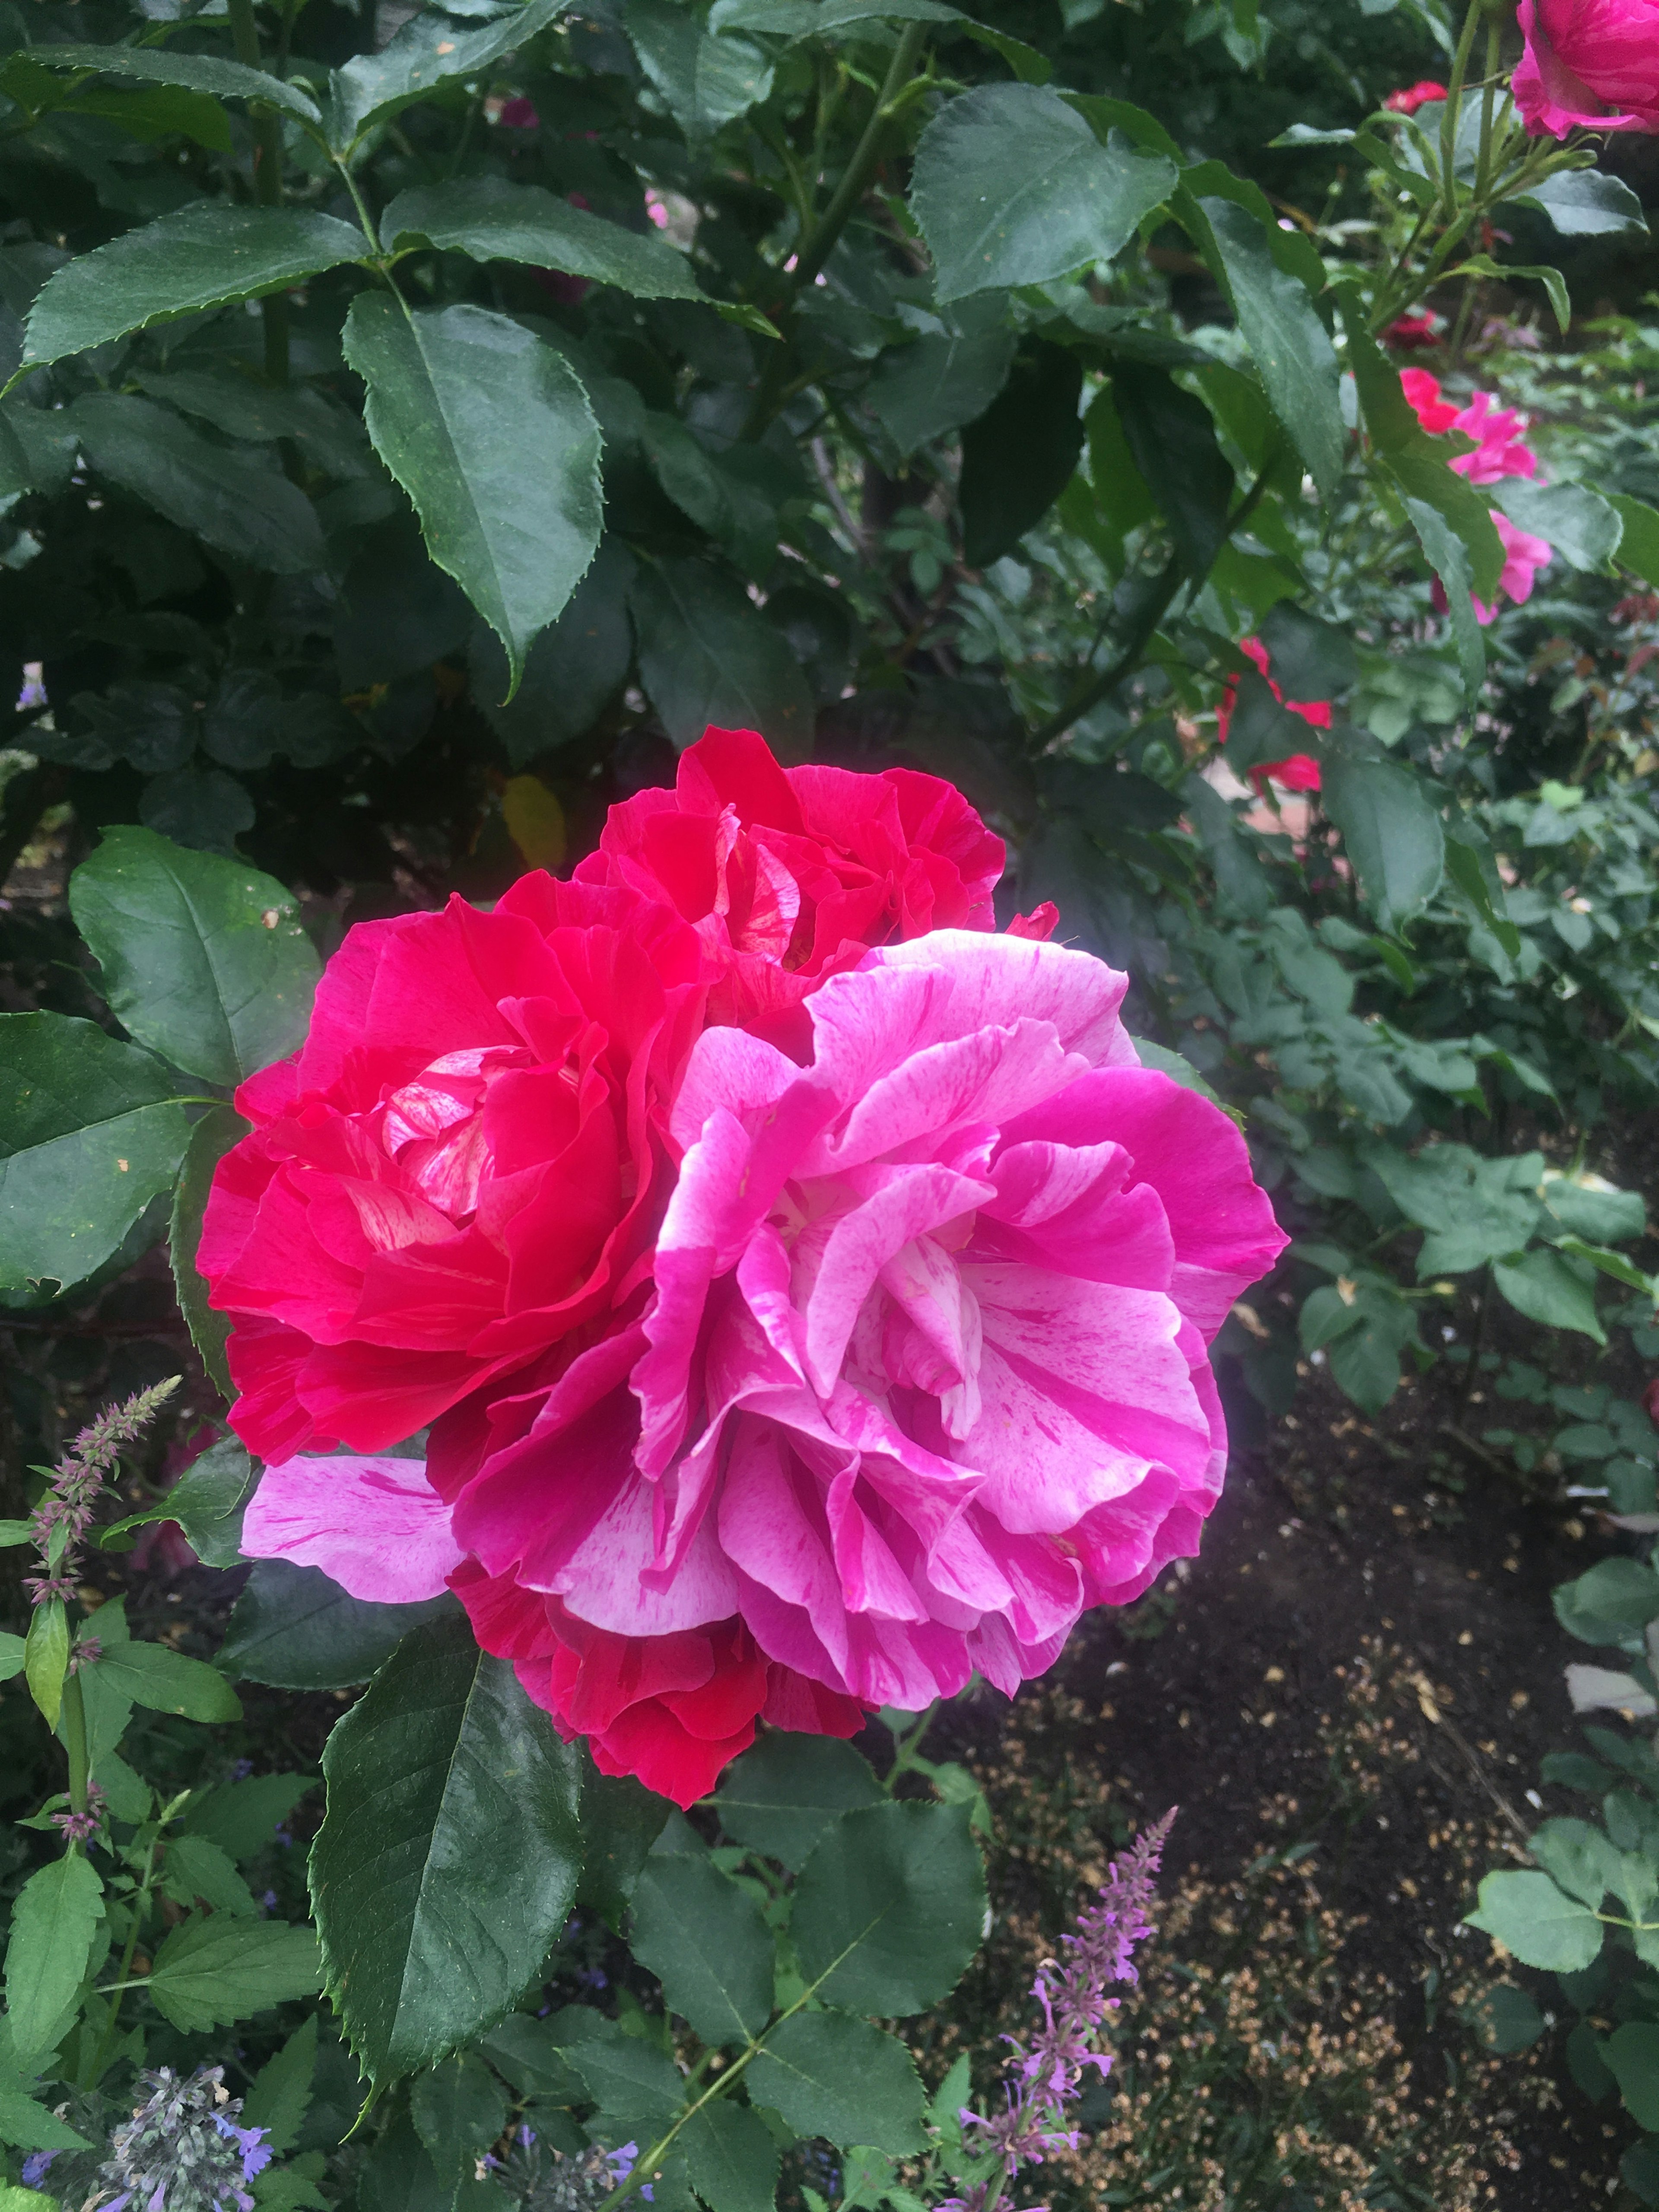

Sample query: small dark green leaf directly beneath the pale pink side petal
[219,1560,456,1690]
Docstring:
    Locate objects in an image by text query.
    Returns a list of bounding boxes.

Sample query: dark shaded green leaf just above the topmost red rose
[630,559,814,761]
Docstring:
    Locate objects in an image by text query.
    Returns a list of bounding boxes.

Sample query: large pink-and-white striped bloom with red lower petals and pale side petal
[245,929,1283,1803]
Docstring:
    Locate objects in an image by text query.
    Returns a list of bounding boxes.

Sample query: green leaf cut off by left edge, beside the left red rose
[0,1013,190,1305]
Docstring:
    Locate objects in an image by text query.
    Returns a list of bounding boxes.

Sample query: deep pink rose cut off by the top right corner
[1513,0,1659,137]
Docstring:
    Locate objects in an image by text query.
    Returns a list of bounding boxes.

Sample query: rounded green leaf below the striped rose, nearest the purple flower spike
[790,1803,984,2020]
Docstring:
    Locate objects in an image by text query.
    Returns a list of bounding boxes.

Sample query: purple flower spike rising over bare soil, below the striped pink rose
[940,1807,1175,2212]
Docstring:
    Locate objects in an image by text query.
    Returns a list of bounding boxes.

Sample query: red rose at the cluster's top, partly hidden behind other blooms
[575,730,1004,1042]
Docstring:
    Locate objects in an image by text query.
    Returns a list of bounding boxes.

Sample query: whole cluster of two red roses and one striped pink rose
[199,730,1283,1803]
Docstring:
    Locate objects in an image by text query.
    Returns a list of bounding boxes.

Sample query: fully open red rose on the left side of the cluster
[197,874,710,1460]
